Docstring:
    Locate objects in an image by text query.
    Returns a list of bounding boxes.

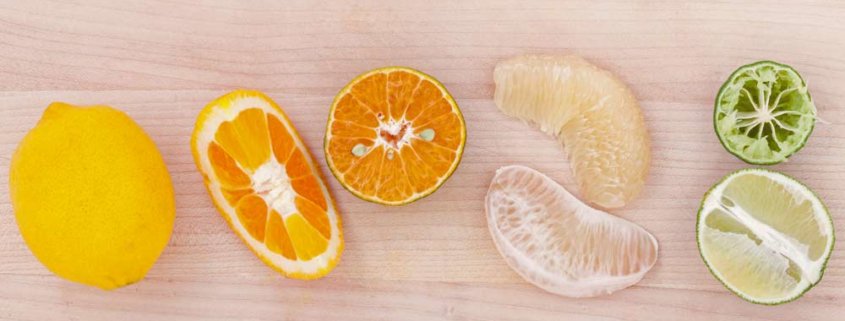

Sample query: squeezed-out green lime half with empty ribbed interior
[713,61,816,165]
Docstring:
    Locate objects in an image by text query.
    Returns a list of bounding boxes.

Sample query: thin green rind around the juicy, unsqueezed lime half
[695,168,836,305]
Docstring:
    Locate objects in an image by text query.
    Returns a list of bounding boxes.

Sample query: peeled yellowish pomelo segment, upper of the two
[494,55,651,208]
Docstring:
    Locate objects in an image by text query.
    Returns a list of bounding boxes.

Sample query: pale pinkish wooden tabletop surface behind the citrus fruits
[0,0,845,321]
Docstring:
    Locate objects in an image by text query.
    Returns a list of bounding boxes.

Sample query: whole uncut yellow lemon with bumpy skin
[9,103,176,289]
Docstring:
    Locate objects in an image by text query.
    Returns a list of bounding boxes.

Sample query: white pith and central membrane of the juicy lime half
[697,169,833,304]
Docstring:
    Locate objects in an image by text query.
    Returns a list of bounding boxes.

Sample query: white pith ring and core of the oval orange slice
[196,96,341,274]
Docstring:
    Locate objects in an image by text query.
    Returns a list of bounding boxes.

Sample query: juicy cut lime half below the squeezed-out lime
[696,169,834,304]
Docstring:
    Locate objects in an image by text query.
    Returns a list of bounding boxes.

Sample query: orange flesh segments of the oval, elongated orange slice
[208,108,331,261]
